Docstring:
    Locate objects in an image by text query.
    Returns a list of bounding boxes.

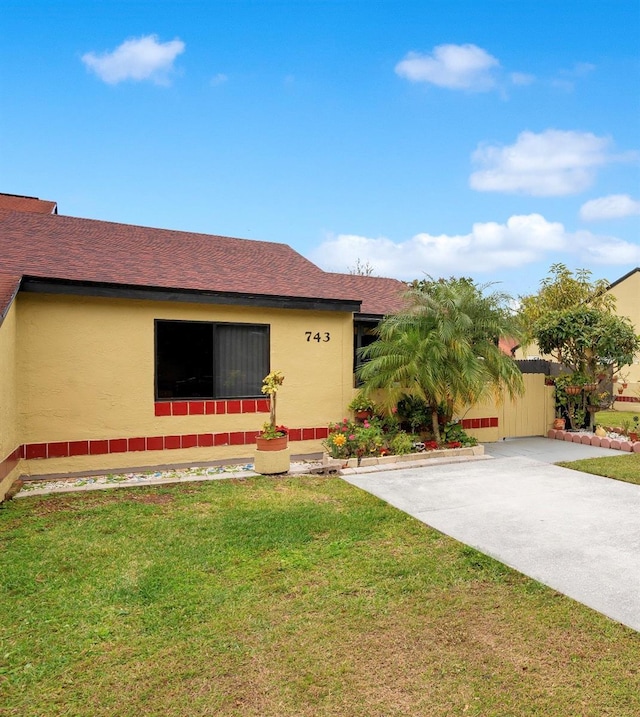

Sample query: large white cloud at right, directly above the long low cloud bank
[469,129,622,197]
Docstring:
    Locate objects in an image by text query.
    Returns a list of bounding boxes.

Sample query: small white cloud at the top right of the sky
[395,45,500,92]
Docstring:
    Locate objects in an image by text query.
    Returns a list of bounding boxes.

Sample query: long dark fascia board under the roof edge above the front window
[21,277,360,313]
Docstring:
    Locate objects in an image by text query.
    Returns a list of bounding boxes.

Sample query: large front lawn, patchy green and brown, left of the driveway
[0,477,640,717]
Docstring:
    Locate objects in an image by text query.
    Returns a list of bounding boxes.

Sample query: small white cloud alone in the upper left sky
[82,35,185,85]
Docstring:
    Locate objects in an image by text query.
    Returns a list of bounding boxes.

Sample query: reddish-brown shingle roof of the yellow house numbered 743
[0,210,401,314]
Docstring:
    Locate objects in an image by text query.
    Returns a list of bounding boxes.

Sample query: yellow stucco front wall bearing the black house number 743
[17,294,353,475]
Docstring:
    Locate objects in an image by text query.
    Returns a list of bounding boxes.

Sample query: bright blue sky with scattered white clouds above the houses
[0,0,640,295]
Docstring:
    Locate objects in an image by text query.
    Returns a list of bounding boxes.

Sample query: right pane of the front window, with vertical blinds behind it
[215,324,269,398]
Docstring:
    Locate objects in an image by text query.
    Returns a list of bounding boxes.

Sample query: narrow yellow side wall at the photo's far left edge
[0,304,20,500]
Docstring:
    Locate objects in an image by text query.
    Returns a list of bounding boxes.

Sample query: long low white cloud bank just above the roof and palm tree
[310,214,640,280]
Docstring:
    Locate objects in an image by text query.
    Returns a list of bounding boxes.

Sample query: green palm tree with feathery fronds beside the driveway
[359,277,523,441]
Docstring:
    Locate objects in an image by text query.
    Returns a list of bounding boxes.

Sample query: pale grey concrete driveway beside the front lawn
[343,438,640,631]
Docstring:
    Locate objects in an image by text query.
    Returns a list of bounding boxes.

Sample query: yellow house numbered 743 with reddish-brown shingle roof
[0,195,405,500]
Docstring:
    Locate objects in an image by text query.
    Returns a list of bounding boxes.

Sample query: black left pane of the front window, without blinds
[156,321,213,398]
